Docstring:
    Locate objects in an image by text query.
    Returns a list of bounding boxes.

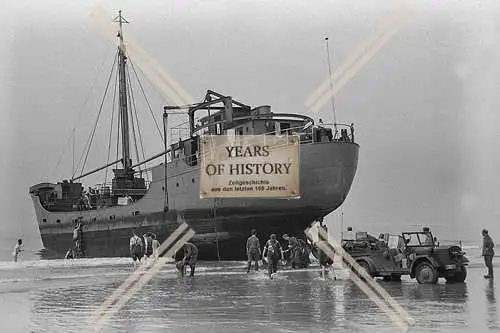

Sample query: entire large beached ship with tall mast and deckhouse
[29,13,359,260]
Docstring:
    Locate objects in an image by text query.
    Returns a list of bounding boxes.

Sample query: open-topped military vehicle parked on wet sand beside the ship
[342,228,469,284]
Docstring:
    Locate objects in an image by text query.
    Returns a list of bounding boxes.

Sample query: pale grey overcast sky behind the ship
[0,0,500,246]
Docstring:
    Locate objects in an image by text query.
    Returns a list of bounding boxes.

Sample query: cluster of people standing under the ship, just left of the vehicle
[246,229,332,279]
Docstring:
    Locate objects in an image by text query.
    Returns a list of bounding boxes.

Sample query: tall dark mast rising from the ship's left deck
[113,10,132,172]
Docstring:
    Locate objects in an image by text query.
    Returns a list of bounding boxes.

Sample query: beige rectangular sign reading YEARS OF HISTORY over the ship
[200,135,300,198]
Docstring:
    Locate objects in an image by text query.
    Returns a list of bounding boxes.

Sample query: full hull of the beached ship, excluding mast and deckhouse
[32,142,359,260]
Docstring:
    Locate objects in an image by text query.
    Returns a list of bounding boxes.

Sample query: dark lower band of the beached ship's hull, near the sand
[38,209,332,260]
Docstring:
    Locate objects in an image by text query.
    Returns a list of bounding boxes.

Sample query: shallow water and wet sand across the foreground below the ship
[0,253,500,333]
